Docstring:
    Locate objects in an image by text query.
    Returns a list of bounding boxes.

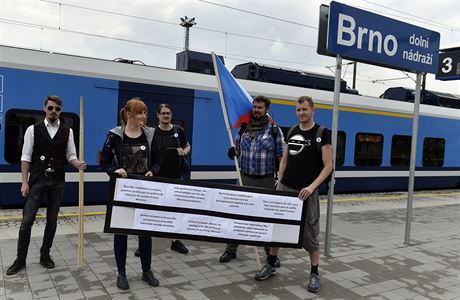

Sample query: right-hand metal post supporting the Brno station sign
[404,72,422,245]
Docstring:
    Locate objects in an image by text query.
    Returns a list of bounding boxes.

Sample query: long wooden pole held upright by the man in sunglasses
[77,96,85,268]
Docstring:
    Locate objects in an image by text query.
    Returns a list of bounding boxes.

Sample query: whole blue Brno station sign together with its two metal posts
[317,1,442,255]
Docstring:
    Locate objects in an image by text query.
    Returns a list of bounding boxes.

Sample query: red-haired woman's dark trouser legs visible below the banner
[113,234,152,274]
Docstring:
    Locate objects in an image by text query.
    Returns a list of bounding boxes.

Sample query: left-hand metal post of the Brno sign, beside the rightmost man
[324,55,342,257]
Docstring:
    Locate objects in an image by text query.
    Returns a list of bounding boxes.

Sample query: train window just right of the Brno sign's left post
[355,133,383,166]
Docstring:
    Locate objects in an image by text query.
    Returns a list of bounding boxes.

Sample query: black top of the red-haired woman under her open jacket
[121,132,149,175]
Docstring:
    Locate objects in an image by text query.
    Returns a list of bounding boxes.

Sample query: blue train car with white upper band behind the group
[0,46,460,207]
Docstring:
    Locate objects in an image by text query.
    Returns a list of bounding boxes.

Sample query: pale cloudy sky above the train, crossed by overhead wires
[0,0,460,97]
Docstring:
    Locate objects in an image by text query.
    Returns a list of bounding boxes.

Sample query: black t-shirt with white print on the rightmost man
[281,124,331,189]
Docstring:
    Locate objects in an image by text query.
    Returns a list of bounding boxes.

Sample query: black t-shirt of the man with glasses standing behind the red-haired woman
[153,125,187,178]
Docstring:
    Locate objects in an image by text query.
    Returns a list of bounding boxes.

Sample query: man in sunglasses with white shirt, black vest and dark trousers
[6,96,86,275]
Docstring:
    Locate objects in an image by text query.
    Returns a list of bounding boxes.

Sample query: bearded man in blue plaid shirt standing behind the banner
[219,96,285,267]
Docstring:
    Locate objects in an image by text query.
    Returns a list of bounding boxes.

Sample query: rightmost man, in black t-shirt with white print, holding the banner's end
[255,96,332,293]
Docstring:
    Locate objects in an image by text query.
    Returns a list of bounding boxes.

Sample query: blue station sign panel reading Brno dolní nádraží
[327,1,440,74]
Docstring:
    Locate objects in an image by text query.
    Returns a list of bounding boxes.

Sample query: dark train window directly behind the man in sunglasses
[4,109,80,164]
